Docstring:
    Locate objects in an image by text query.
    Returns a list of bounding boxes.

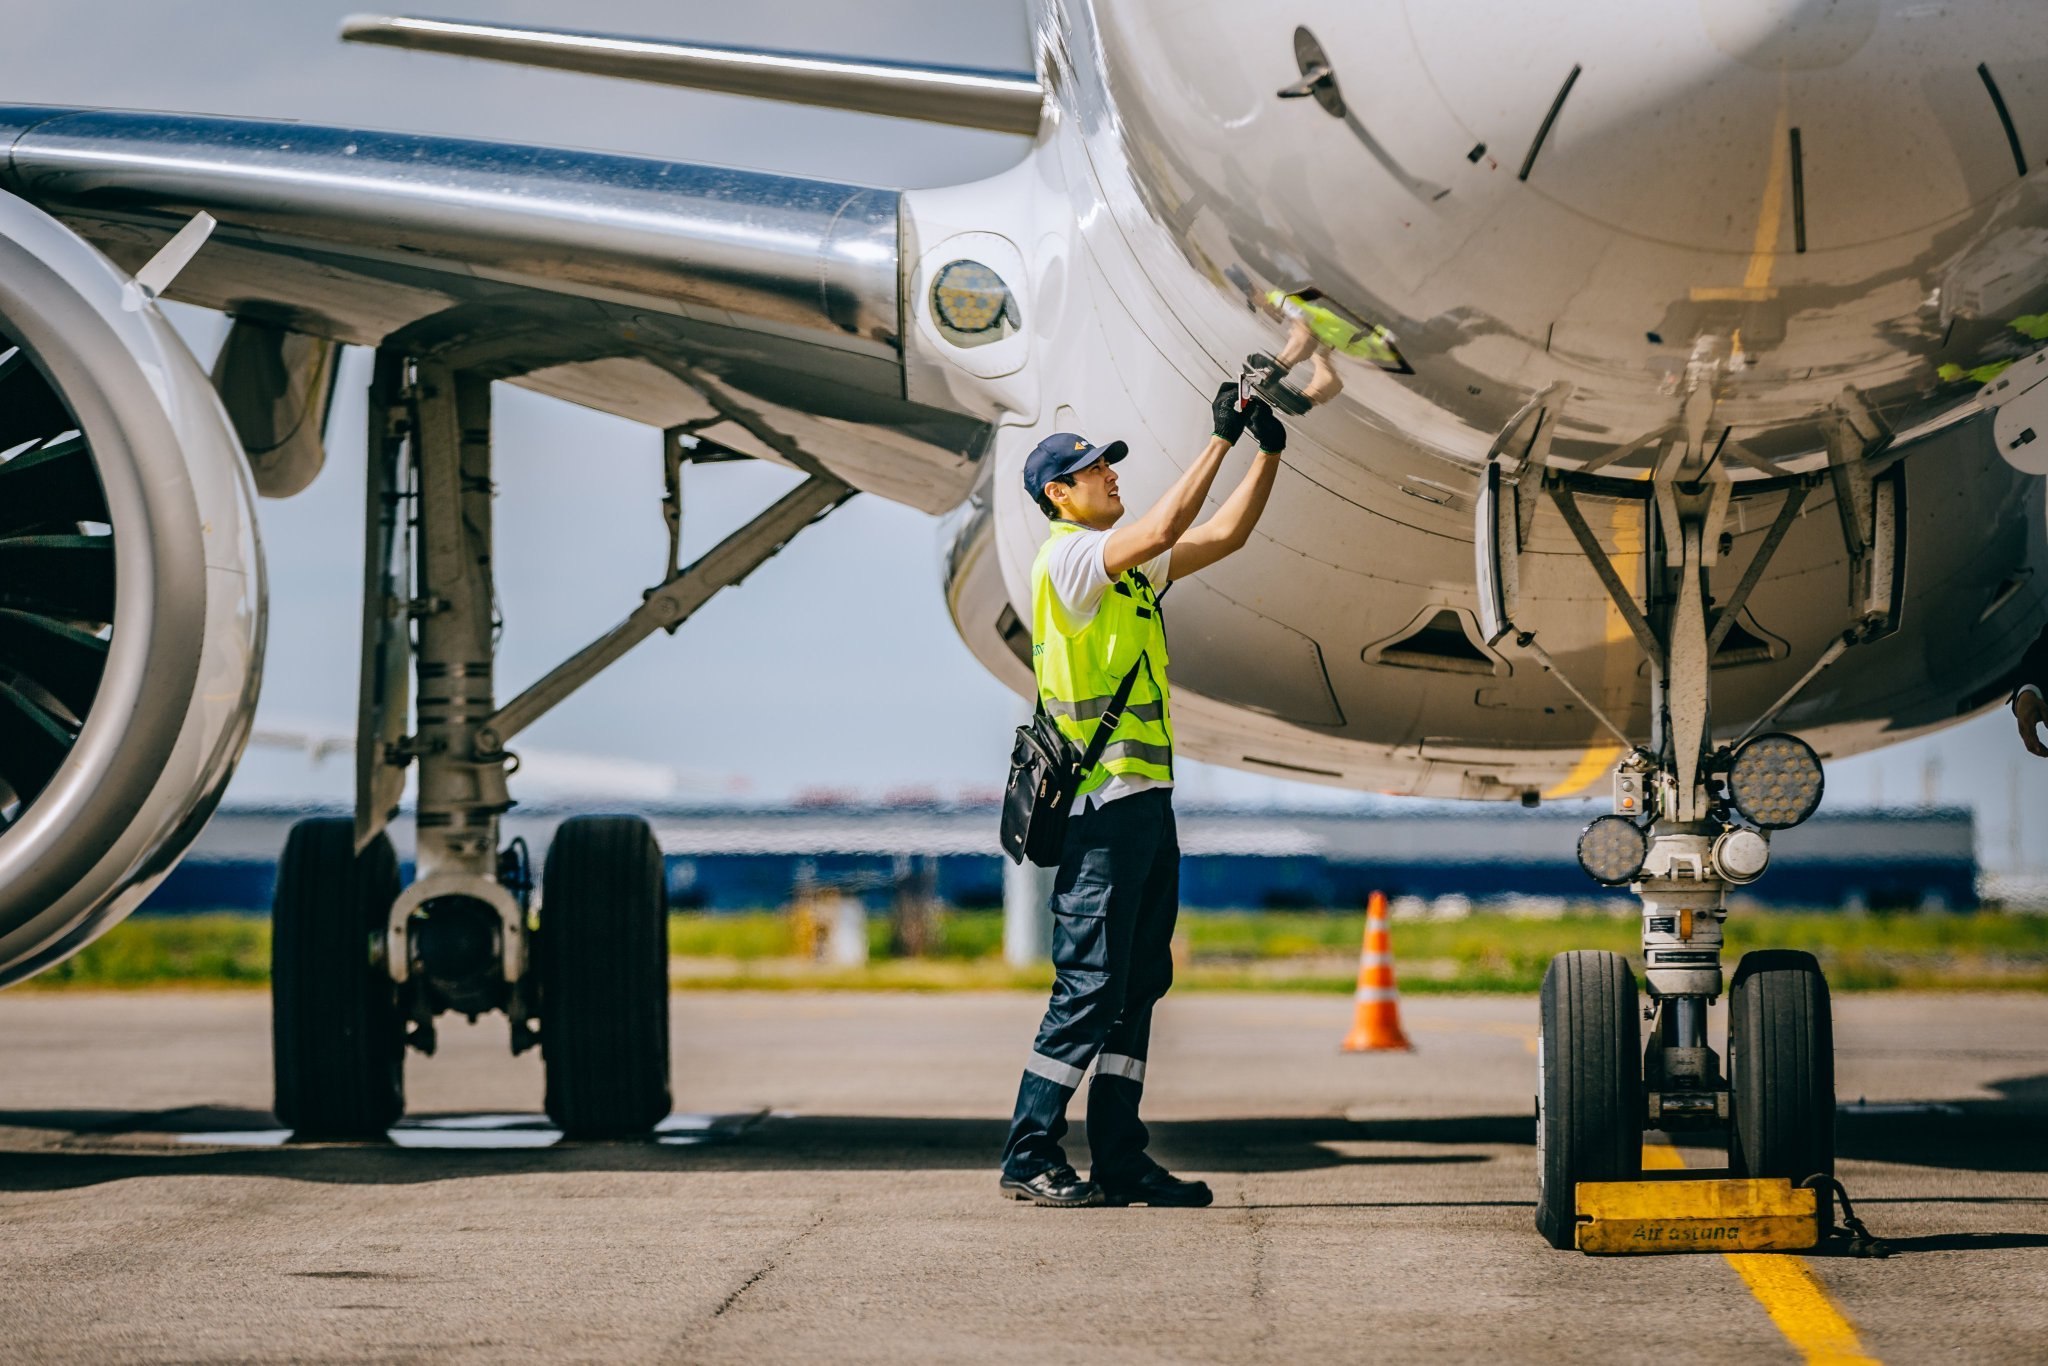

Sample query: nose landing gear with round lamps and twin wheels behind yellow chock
[1477,371,1905,1247]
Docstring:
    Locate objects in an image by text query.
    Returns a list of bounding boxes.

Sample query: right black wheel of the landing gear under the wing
[535,815,670,1139]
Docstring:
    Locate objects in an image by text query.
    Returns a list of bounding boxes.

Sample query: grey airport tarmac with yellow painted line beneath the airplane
[0,991,2048,1364]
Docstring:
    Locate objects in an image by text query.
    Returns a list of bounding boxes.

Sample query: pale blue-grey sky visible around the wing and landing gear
[0,0,2048,868]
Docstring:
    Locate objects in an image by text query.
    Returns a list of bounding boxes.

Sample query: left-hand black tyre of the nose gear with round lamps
[1536,950,1642,1249]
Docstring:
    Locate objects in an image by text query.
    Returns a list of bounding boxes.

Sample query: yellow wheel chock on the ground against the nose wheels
[1577,1178,1821,1253]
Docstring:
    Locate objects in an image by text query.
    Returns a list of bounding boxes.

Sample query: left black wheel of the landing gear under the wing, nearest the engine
[270,817,406,1139]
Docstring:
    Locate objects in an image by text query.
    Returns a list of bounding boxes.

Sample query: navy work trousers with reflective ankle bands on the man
[1004,788,1180,1182]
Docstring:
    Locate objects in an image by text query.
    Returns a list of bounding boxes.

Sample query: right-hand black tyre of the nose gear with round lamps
[1729,948,1835,1231]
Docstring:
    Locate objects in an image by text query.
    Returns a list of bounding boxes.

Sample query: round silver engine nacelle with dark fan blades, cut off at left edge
[0,195,264,985]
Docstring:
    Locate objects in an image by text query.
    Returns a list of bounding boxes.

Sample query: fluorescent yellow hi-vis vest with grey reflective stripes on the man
[1030,522,1174,797]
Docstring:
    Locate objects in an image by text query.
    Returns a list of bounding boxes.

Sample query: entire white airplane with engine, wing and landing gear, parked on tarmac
[0,0,2048,1247]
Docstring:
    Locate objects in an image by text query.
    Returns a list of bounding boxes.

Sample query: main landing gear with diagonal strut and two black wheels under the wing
[270,350,852,1139]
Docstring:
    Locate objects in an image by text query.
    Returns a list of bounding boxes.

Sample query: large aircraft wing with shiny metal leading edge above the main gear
[0,106,989,512]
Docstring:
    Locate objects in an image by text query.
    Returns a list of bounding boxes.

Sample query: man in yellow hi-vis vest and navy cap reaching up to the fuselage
[1001,381,1286,1206]
